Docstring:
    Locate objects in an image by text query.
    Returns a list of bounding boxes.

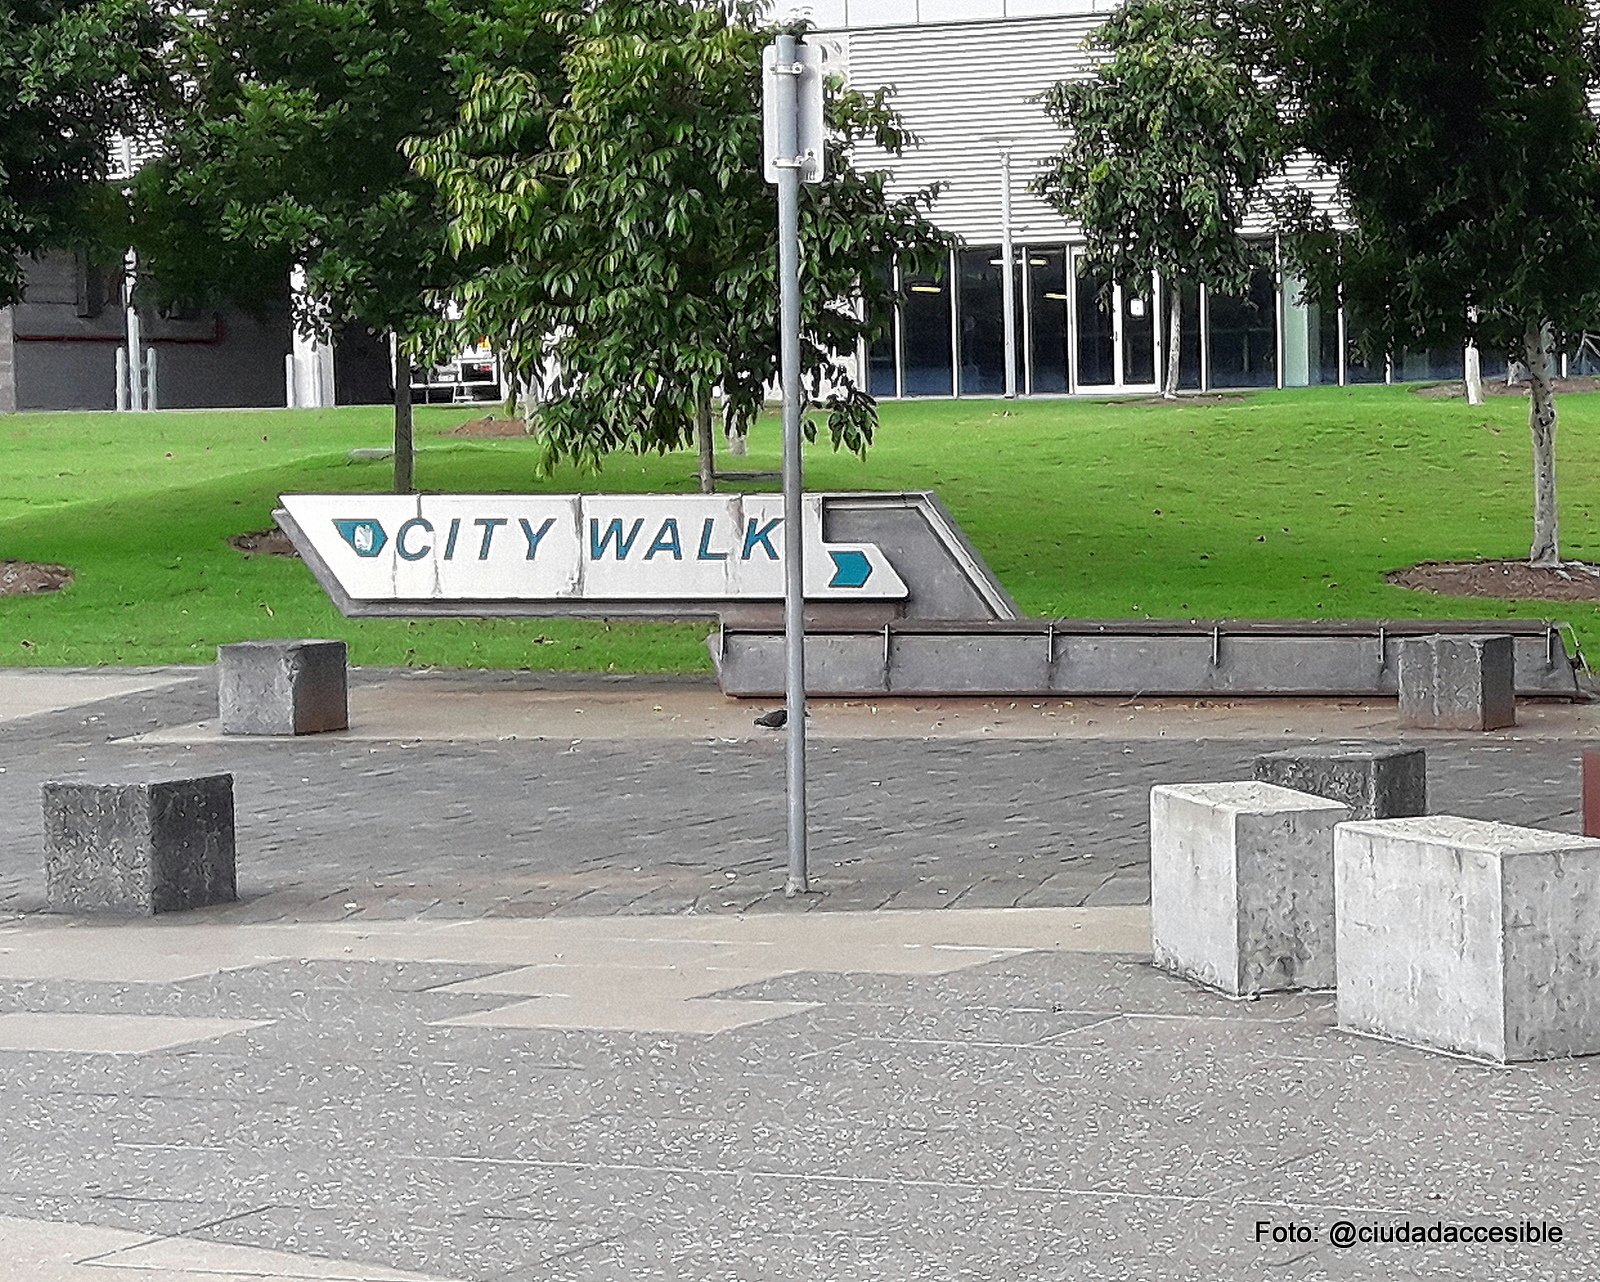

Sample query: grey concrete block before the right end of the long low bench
[1400,635,1517,730]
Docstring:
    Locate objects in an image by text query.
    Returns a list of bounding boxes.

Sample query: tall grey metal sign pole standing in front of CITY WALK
[773,35,810,896]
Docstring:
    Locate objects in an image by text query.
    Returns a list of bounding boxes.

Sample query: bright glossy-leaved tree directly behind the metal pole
[411,0,947,490]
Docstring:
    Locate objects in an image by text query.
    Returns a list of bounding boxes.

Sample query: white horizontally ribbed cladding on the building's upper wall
[829,13,1338,243]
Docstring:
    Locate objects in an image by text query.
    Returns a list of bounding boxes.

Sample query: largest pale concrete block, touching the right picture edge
[1334,815,1600,1061]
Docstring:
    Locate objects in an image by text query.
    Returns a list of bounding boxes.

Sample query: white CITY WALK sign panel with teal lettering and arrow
[282,495,907,602]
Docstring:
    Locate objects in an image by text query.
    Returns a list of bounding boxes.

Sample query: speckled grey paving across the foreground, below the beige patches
[0,954,1600,1282]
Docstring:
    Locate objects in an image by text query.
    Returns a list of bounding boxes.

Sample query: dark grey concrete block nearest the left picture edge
[43,775,238,915]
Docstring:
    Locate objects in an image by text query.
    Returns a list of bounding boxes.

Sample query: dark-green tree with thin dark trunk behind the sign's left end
[139,0,556,491]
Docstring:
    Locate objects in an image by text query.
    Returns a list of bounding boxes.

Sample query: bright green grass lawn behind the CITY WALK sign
[0,387,1600,672]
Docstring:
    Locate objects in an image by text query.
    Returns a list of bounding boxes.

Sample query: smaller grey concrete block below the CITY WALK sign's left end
[216,640,350,735]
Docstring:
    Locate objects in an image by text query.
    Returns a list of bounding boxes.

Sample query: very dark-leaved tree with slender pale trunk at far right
[1253,0,1600,565]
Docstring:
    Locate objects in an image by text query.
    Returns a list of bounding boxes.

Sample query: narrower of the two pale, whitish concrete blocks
[1150,783,1350,994]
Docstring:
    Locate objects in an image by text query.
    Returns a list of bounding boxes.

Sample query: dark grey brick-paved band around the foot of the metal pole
[0,674,1579,920]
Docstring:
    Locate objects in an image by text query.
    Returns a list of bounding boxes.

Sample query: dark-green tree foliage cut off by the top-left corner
[0,0,168,307]
